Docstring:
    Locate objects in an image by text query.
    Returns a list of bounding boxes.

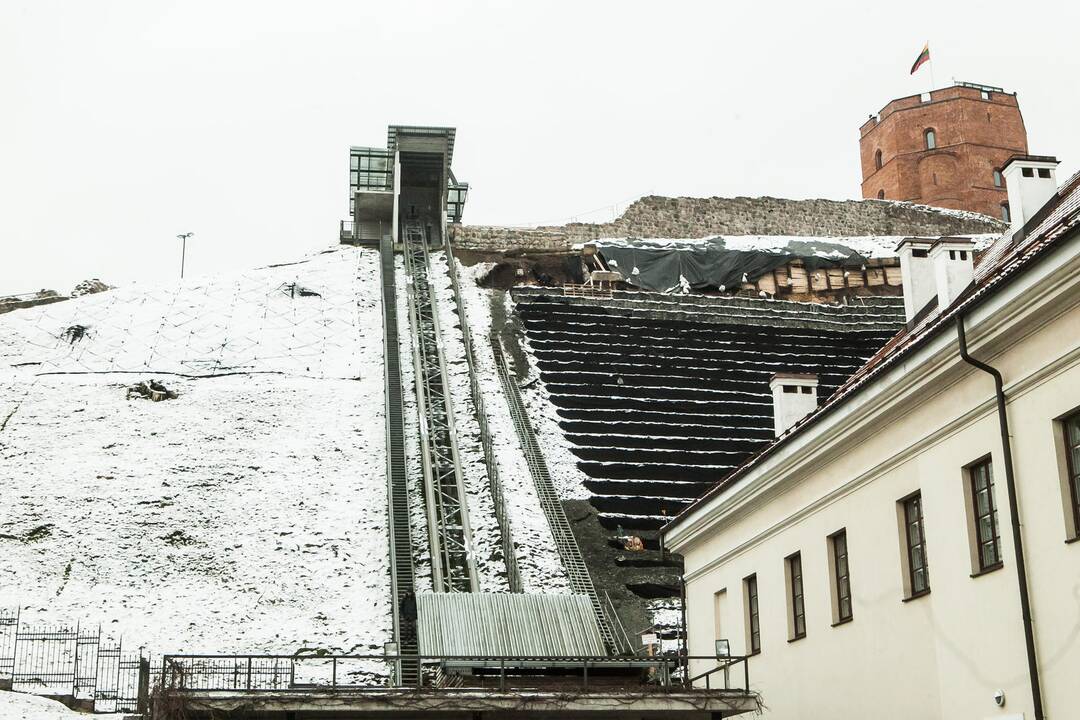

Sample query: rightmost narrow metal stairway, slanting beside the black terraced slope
[491,335,620,652]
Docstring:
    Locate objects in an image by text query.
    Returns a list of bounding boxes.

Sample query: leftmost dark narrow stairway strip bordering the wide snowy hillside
[379,237,419,685]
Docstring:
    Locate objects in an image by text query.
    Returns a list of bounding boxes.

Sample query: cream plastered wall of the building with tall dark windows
[675,291,1080,719]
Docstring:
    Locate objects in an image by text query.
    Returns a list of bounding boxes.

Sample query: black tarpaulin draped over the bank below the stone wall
[595,237,866,293]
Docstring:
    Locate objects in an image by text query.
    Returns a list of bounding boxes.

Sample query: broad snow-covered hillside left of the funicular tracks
[0,247,390,652]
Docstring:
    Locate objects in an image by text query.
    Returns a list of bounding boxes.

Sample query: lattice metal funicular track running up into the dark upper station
[402,220,480,593]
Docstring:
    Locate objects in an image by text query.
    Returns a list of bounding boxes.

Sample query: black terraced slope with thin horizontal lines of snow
[514,288,903,530]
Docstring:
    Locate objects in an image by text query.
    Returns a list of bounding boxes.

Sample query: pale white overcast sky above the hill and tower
[0,0,1080,294]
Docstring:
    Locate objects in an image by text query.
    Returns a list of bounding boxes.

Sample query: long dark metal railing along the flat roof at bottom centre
[161,655,751,694]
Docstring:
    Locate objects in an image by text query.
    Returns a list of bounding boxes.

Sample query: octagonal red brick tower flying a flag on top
[859,82,1027,219]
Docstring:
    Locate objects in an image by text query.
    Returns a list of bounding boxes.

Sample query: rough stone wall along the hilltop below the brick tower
[451,195,1007,250]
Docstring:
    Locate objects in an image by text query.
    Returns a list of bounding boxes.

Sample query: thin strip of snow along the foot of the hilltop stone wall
[587,234,999,259]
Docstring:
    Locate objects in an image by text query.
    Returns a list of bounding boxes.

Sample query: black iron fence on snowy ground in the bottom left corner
[0,610,150,712]
